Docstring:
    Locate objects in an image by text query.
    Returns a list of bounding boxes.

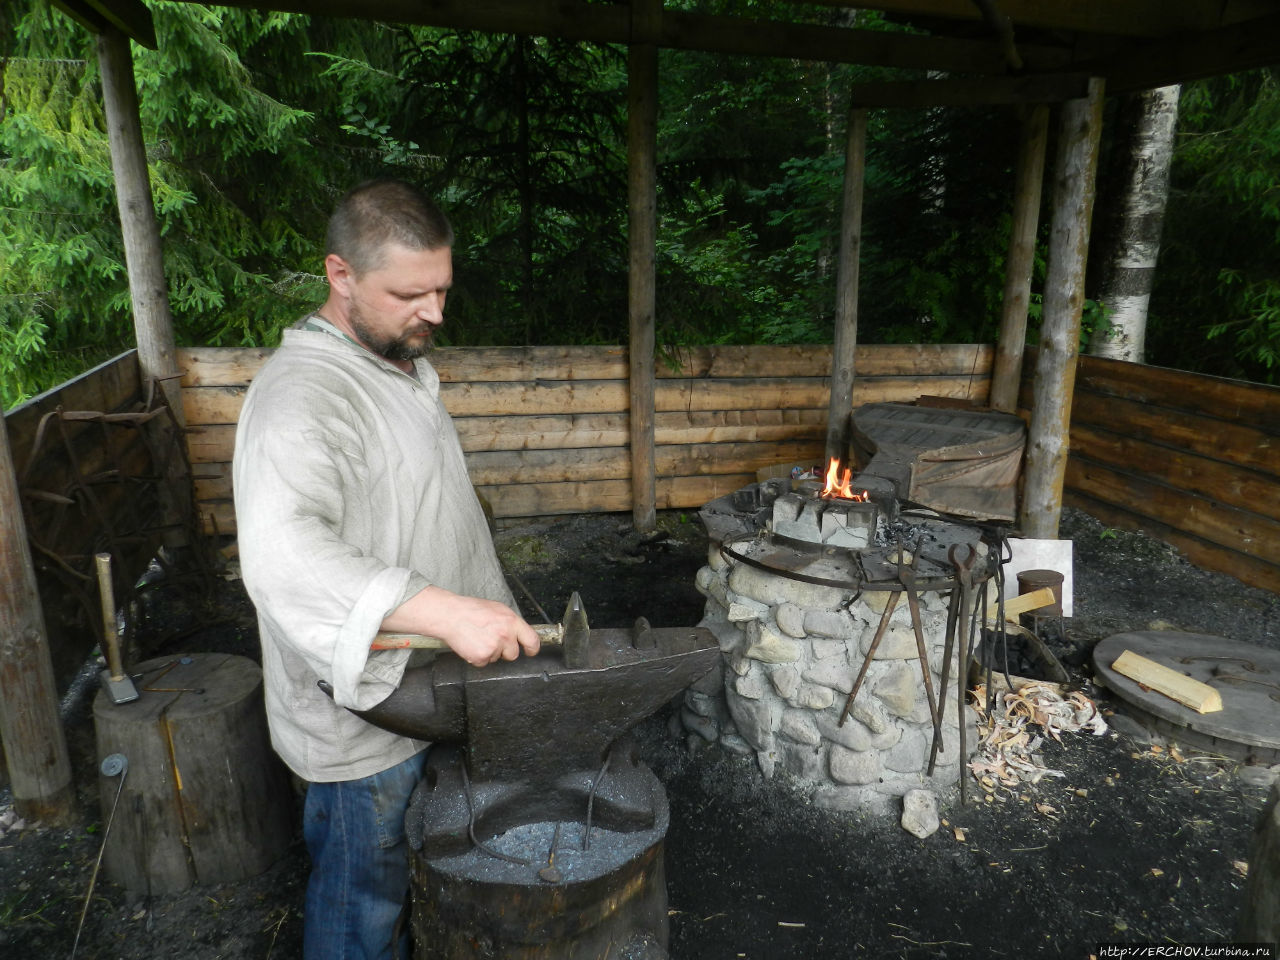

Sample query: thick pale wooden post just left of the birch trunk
[1020,78,1103,540]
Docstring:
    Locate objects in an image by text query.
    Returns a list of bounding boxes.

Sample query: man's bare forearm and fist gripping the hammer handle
[381,586,540,667]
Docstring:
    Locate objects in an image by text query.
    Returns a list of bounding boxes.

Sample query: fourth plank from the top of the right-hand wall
[1066,457,1280,564]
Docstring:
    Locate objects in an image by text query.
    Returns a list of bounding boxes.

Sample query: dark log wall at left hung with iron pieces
[4,351,160,689]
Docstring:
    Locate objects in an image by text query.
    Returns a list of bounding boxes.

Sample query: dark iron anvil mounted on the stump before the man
[350,621,719,782]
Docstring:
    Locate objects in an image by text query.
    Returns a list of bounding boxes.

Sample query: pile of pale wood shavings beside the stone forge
[969,684,1107,793]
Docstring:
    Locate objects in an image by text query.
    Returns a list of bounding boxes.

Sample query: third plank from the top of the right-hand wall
[1071,424,1280,520]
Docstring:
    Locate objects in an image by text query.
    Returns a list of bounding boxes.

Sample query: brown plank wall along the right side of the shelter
[1023,356,1280,591]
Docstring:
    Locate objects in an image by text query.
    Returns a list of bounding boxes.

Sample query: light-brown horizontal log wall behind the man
[179,344,992,534]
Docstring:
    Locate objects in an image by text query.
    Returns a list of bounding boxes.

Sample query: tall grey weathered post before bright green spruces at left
[97,27,191,547]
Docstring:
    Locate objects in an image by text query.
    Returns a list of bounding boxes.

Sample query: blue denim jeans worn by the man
[302,753,426,960]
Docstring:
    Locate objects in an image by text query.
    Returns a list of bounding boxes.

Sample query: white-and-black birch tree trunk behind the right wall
[1089,83,1181,364]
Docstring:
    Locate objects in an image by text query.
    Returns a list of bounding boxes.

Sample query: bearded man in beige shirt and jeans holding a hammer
[233,180,538,960]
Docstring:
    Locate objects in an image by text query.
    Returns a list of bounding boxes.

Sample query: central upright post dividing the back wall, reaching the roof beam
[627,0,662,531]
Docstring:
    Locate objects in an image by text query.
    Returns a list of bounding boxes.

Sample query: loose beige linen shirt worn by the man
[233,329,516,781]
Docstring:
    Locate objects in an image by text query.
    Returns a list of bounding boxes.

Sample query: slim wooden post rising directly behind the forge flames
[826,106,867,463]
